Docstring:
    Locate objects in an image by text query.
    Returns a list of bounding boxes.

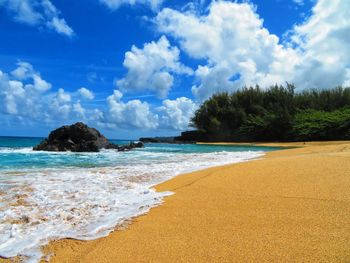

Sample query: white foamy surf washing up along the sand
[0,151,263,262]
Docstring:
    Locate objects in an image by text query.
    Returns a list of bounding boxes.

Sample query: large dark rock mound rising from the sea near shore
[33,122,118,152]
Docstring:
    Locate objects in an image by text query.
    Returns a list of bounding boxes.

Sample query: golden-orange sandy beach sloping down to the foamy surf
[38,142,350,262]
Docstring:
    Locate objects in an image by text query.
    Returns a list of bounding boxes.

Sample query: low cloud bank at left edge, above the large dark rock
[0,62,98,123]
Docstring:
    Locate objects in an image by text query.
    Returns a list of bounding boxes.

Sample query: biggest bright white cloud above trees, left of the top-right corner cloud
[155,1,297,100]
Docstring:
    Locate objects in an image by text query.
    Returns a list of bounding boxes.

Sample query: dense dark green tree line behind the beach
[189,83,350,141]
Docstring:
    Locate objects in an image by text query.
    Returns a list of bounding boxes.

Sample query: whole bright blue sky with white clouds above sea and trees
[0,0,350,139]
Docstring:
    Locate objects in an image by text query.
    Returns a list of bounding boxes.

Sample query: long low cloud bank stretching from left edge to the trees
[0,61,197,130]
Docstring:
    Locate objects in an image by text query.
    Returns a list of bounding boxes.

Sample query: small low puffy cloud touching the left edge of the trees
[158,97,197,130]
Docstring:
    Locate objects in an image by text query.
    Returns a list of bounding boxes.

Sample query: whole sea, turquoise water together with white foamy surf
[0,137,278,262]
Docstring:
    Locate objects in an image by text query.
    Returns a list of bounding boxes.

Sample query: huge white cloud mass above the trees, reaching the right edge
[155,0,350,101]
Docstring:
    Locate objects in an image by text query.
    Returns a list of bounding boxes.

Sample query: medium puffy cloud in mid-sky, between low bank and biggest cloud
[117,36,192,98]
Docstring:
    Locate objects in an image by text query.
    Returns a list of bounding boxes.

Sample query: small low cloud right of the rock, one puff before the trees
[106,90,158,129]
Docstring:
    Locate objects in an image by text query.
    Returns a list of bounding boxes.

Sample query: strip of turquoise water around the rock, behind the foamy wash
[0,137,278,171]
